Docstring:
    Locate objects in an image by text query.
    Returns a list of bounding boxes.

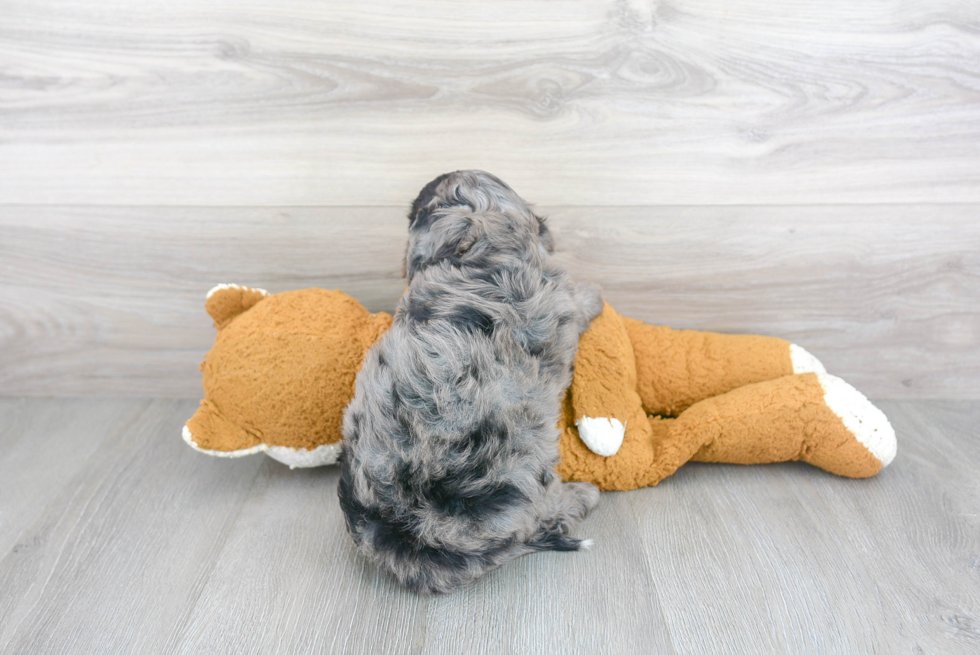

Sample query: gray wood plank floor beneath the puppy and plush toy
[0,399,980,655]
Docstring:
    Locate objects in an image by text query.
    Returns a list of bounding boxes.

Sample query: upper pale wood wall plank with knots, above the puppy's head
[0,0,980,206]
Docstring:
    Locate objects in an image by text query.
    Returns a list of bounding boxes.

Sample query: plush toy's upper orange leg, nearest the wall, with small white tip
[622,318,826,416]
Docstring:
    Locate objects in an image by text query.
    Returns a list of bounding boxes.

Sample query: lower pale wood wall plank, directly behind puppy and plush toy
[0,205,980,398]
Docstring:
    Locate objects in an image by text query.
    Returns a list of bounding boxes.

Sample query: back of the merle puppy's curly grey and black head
[405,171,554,282]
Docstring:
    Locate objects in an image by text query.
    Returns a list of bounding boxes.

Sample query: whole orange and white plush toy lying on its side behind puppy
[184,285,896,490]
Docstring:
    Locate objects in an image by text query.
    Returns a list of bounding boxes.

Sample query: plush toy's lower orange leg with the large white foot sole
[670,373,896,478]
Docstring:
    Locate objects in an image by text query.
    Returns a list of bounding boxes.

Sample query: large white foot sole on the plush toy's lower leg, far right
[817,374,898,468]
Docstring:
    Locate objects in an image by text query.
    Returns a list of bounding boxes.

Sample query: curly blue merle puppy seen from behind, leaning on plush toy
[339,171,602,593]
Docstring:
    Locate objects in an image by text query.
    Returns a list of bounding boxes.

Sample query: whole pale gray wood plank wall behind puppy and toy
[0,0,980,398]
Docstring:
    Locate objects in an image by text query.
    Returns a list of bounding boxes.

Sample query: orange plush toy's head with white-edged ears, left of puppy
[184,284,392,467]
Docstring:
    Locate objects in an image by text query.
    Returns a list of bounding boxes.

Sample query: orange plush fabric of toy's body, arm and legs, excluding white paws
[558,304,894,490]
